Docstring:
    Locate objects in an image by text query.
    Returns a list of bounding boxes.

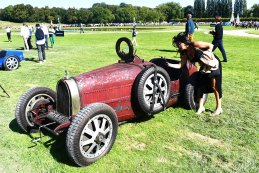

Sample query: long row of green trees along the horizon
[0,0,259,24]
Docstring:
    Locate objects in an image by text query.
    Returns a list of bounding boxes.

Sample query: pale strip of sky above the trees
[0,0,259,9]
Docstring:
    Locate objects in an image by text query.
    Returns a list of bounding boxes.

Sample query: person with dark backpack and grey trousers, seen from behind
[35,24,46,63]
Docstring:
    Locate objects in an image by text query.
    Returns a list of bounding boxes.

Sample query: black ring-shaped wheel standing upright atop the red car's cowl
[115,37,134,62]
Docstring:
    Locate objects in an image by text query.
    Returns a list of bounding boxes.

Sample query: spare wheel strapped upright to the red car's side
[133,67,171,114]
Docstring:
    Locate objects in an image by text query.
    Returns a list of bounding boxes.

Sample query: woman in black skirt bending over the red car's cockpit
[168,33,223,116]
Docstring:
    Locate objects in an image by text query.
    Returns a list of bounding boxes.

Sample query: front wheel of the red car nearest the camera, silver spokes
[66,103,118,166]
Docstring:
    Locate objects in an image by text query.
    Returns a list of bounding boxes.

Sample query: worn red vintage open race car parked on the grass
[15,37,196,166]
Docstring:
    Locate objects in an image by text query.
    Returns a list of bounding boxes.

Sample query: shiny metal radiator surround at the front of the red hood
[64,78,81,115]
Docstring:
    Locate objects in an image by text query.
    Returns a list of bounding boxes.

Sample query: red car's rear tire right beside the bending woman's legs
[184,73,198,110]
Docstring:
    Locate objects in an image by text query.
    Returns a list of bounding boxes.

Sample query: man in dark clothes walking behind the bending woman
[210,16,227,62]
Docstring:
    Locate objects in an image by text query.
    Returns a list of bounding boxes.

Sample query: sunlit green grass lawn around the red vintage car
[0,27,259,173]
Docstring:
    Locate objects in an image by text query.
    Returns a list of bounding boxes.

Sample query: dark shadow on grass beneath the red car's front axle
[9,119,77,167]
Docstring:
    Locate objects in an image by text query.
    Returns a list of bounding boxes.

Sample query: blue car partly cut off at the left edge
[0,50,24,71]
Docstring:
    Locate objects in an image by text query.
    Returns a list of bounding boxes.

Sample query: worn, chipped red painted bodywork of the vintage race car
[74,58,196,121]
